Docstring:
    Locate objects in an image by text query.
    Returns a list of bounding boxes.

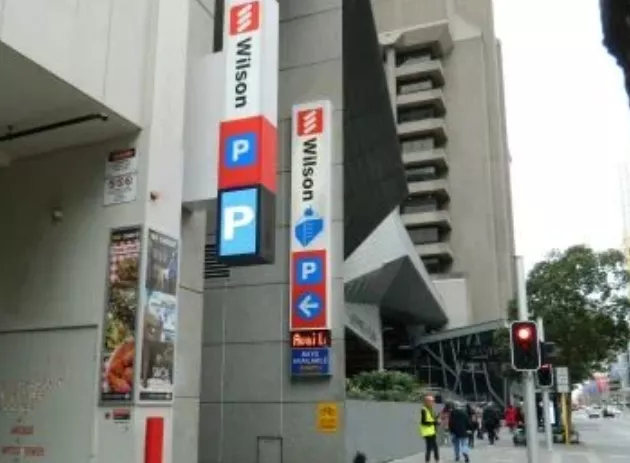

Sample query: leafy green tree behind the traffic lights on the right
[495,245,630,383]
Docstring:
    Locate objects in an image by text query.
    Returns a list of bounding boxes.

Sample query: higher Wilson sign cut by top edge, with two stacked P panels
[217,0,279,265]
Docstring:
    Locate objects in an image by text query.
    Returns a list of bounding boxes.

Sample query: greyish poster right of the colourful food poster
[139,230,179,402]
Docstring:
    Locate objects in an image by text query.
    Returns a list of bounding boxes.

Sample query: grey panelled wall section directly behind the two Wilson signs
[199,0,345,463]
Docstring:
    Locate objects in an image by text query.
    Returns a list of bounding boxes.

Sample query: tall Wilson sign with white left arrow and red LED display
[290,101,332,376]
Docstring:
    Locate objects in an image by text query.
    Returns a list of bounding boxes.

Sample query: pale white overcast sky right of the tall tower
[494,0,630,267]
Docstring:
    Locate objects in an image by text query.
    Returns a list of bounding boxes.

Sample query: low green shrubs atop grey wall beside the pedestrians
[346,371,425,402]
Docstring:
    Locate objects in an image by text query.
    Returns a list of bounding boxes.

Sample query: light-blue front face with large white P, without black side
[218,188,258,257]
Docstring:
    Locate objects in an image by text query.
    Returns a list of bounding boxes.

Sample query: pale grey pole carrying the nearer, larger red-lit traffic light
[515,256,538,463]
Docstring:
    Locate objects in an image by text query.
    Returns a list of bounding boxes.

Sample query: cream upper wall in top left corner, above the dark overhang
[0,0,159,126]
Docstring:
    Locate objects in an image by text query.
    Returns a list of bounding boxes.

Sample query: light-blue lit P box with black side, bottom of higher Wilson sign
[217,186,276,266]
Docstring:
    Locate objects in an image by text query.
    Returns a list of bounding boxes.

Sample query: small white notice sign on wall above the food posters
[103,148,138,206]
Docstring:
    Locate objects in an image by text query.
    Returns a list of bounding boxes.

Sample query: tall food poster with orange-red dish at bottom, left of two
[100,226,142,402]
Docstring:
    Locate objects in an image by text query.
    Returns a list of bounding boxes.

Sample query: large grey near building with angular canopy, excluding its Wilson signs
[0,0,448,463]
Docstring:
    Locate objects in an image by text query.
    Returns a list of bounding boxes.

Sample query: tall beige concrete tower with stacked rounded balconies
[372,0,514,328]
